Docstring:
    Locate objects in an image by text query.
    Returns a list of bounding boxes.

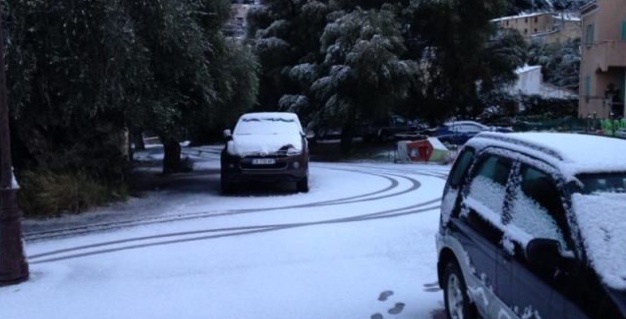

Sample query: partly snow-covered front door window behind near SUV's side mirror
[505,164,567,248]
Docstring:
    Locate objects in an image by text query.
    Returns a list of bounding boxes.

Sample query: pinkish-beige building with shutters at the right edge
[578,0,626,119]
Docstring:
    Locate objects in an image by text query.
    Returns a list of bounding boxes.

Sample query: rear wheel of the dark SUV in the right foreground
[443,261,478,319]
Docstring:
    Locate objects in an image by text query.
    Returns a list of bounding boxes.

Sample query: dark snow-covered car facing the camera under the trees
[221,112,309,193]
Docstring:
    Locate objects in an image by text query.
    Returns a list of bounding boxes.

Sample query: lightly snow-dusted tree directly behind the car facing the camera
[248,0,332,114]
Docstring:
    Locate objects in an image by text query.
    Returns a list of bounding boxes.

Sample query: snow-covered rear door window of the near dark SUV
[468,154,512,224]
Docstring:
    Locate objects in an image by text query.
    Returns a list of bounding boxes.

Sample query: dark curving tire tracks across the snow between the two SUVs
[23,162,447,263]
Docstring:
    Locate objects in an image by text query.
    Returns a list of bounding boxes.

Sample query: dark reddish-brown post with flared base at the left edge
[0,0,29,286]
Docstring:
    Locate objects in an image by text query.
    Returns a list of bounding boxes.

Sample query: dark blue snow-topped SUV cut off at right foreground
[436,132,626,319]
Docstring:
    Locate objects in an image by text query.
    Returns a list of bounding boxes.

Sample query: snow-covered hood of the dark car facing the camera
[228,134,304,156]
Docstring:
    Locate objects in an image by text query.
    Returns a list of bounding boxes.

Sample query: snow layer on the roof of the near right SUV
[470,132,626,179]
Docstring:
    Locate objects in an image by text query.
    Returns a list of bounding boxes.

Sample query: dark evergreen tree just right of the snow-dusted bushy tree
[409,0,523,123]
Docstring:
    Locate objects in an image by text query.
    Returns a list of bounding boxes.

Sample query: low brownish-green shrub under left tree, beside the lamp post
[18,169,127,217]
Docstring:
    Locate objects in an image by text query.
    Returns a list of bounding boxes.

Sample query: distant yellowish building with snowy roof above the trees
[492,12,582,43]
